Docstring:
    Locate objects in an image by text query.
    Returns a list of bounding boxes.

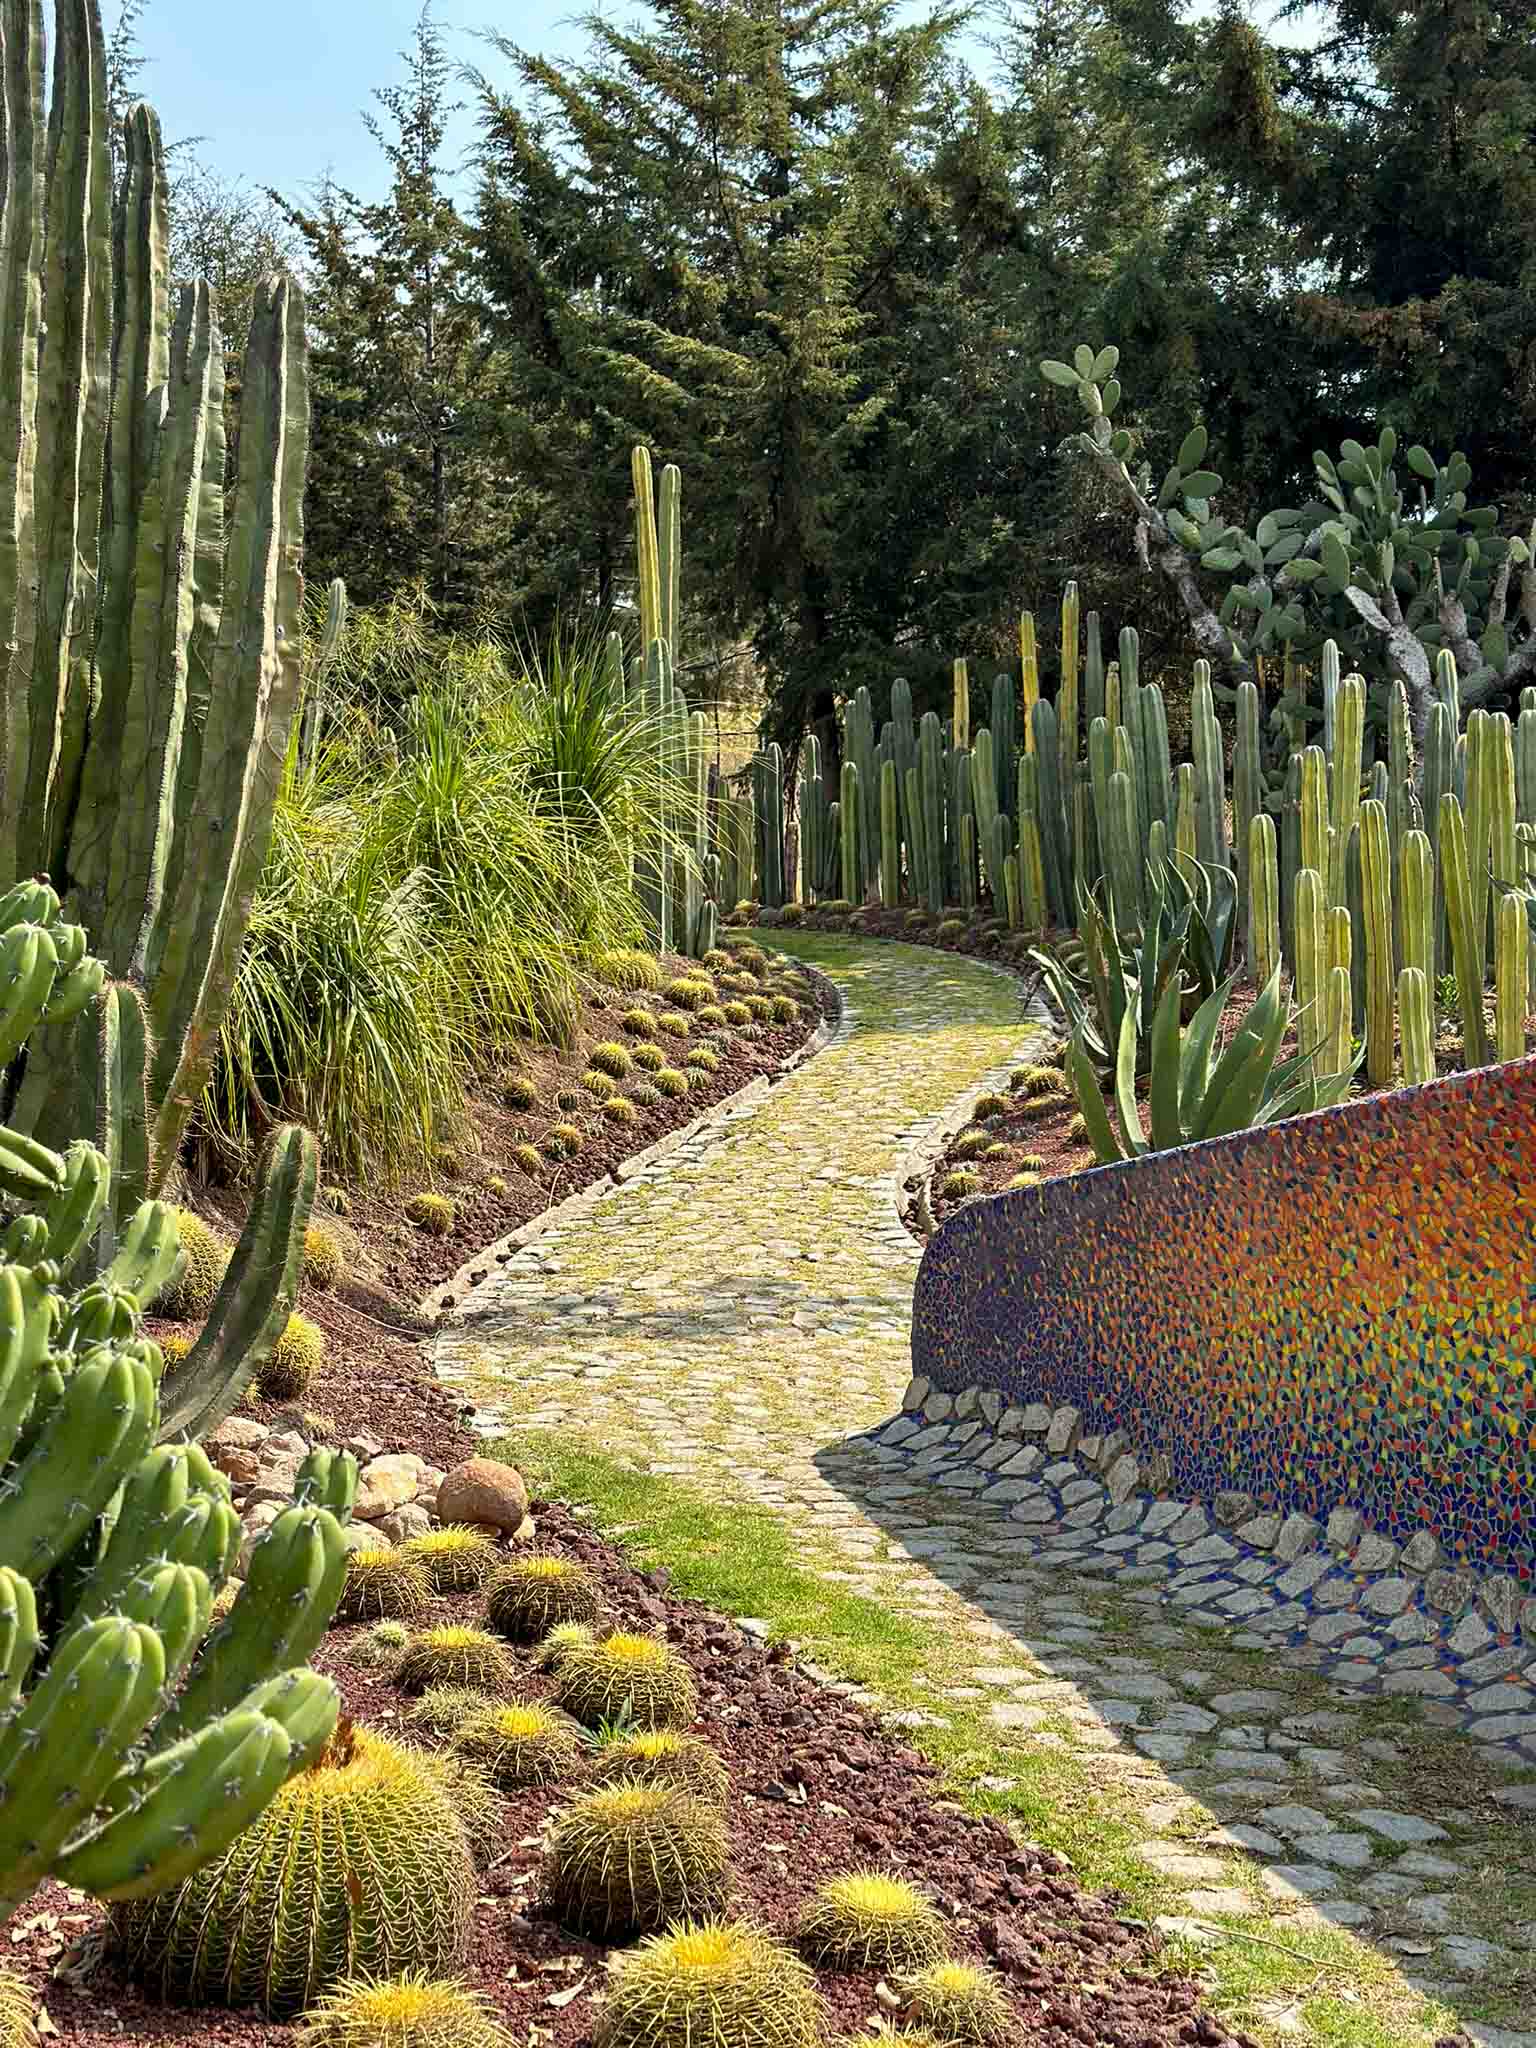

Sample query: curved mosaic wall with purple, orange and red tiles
[911,1059,1536,1579]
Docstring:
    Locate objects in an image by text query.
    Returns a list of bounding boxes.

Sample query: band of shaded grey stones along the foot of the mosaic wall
[876,1378,1536,1763]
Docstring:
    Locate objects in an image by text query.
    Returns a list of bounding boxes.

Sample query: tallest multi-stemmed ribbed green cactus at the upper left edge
[0,0,325,1184]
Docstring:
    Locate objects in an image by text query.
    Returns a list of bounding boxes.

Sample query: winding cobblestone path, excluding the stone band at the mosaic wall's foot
[438,934,1536,2048]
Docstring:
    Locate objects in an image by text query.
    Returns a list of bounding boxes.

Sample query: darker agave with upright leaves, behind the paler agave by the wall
[1030,858,1237,1075]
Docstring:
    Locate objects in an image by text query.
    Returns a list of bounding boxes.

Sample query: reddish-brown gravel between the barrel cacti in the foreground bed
[20,1505,1251,2048]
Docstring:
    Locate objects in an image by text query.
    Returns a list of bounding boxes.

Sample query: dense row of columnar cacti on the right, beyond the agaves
[762,586,1536,1085]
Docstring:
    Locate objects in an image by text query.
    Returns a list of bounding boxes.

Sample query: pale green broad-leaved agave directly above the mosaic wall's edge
[1067,969,1360,1165]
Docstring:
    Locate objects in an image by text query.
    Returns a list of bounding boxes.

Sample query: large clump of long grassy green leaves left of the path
[205,618,692,1178]
